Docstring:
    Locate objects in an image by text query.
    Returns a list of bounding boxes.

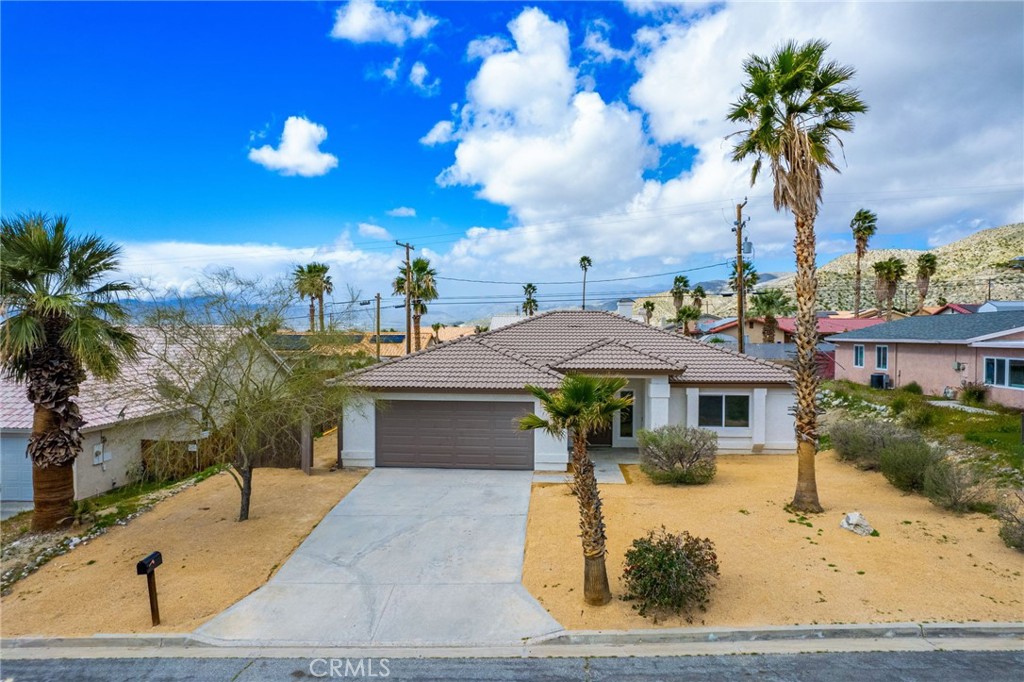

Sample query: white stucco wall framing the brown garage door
[341,392,569,471]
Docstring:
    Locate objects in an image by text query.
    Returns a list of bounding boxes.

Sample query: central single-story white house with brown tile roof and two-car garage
[340,310,796,471]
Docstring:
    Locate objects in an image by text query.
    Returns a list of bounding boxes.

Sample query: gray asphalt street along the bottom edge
[0,651,1024,682]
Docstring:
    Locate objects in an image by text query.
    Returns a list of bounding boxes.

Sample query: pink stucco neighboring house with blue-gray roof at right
[828,310,1024,408]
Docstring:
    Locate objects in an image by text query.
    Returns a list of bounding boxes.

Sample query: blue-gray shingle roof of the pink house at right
[828,310,1024,343]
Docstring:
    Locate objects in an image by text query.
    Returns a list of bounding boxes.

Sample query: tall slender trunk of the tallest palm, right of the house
[793,214,821,512]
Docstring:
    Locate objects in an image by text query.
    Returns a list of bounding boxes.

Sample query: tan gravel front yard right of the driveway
[523,452,1024,630]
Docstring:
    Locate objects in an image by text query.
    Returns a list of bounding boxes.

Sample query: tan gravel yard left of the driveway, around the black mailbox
[2,435,368,637]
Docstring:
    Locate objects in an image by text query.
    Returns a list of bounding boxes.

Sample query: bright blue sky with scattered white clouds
[0,0,1024,327]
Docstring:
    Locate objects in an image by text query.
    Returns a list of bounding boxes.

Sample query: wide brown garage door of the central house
[376,400,534,469]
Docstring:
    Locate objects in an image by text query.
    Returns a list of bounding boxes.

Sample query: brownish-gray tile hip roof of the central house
[349,310,793,390]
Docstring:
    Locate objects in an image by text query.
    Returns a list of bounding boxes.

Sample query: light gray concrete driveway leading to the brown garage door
[196,469,562,646]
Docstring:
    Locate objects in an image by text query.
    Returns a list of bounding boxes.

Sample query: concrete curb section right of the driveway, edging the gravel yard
[529,623,1024,646]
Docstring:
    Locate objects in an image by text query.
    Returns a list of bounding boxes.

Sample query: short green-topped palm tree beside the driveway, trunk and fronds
[519,374,633,605]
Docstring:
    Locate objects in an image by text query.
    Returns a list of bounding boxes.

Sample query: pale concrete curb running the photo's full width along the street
[0,623,1024,652]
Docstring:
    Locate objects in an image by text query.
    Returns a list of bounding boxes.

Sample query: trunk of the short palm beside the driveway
[572,434,611,606]
